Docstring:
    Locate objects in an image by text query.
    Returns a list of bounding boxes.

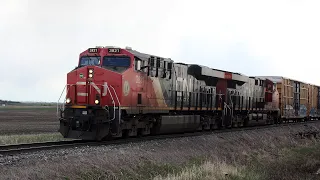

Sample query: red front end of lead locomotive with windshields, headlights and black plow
[59,47,134,140]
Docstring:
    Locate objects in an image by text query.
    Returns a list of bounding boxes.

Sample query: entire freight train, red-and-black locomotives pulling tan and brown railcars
[58,46,320,141]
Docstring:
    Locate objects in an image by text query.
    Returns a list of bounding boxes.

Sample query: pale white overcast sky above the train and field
[0,0,320,102]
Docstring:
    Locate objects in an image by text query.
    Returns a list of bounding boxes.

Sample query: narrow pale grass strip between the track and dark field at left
[0,133,66,145]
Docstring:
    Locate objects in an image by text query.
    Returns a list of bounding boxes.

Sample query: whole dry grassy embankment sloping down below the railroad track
[0,123,320,180]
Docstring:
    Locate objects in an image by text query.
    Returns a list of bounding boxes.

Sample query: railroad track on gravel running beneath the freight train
[0,121,320,155]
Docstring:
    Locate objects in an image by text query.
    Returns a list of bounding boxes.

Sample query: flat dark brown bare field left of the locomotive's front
[0,107,59,135]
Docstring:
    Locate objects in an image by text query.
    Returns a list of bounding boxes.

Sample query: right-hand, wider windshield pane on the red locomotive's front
[102,56,130,73]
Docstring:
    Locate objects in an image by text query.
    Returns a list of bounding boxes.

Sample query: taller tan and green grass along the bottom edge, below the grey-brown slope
[66,143,320,180]
